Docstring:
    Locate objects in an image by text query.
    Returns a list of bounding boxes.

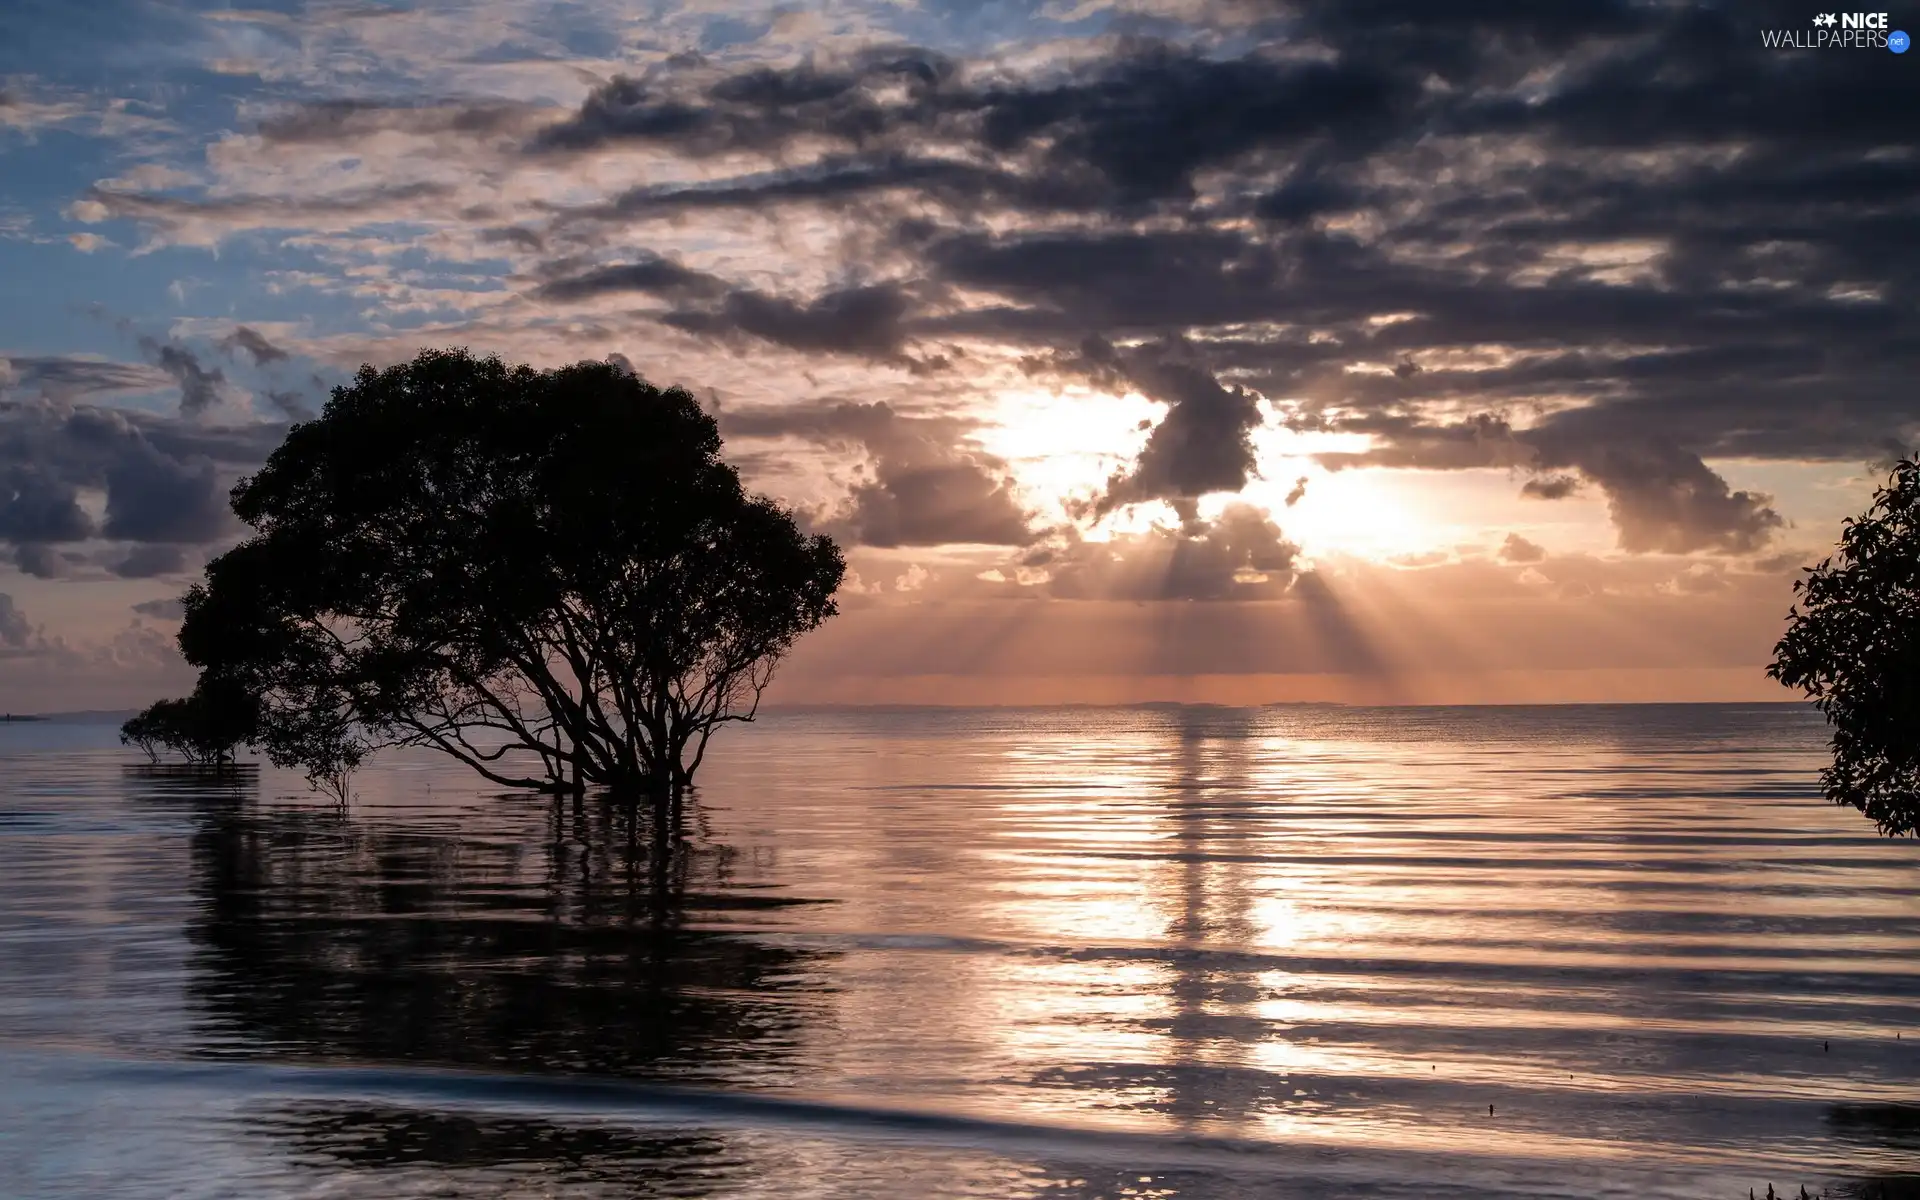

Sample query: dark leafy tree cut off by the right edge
[1766,459,1920,835]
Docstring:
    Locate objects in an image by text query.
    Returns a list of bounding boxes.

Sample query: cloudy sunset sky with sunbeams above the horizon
[0,0,1920,710]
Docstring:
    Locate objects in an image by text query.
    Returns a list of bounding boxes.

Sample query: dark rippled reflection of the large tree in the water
[188,795,828,1192]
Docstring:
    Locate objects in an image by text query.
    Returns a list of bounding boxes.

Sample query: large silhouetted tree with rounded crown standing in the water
[180,351,845,806]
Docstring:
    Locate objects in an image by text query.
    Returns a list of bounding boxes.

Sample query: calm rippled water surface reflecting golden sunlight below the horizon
[0,707,1920,1200]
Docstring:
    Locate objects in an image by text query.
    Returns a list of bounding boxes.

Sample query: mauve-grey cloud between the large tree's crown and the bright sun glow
[722,403,1033,547]
